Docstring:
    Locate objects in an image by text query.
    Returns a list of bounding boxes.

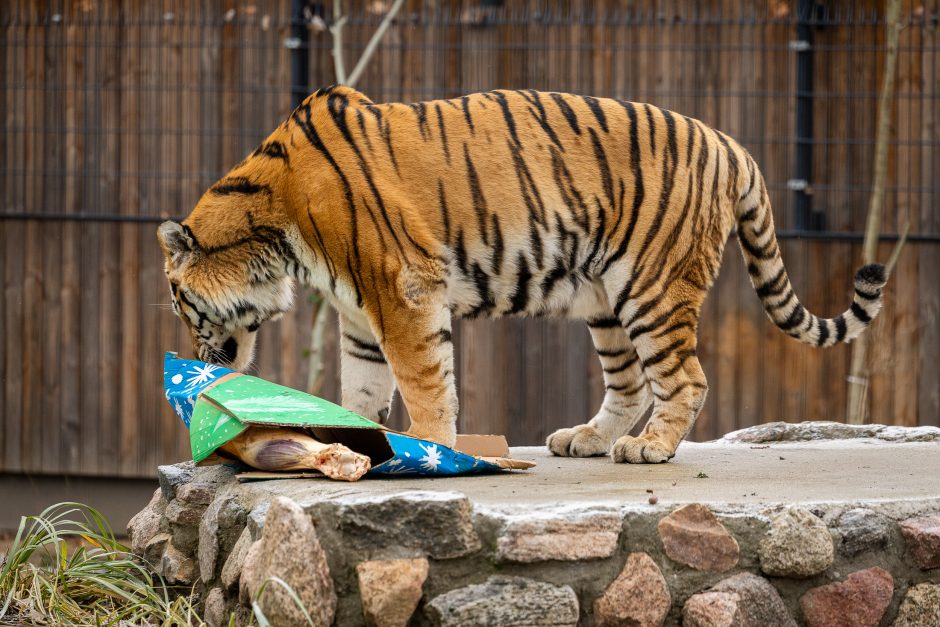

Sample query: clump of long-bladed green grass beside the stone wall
[0,503,204,626]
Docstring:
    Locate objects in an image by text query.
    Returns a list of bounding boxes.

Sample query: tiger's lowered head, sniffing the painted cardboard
[157,174,299,370]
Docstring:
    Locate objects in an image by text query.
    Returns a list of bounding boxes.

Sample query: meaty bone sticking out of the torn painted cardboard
[222,427,371,481]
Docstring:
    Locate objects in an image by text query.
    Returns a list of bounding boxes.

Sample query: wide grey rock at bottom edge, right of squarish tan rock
[426,576,578,627]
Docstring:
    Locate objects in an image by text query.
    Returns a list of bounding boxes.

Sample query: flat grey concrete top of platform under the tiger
[241,440,940,506]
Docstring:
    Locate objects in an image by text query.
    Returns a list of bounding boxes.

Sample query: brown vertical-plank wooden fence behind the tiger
[0,0,940,476]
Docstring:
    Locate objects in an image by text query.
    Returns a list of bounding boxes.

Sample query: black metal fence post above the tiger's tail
[792,0,822,230]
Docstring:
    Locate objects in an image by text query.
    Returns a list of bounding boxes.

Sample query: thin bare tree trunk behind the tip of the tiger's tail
[846,0,901,424]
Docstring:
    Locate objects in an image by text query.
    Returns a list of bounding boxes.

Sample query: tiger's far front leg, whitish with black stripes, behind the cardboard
[339,315,395,424]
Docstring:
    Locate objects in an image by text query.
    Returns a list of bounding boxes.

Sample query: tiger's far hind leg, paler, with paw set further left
[546,316,652,457]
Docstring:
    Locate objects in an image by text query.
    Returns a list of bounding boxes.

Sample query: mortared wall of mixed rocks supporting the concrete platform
[129,463,940,627]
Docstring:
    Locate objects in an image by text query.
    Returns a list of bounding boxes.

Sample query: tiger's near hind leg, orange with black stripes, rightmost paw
[611,291,708,464]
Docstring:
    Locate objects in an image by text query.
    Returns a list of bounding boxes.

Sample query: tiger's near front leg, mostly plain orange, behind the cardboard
[373,270,458,446]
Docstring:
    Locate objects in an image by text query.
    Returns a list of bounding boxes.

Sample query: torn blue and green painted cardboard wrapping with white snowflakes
[163,353,534,479]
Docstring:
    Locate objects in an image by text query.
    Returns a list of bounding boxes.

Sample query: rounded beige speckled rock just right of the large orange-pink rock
[757,507,835,577]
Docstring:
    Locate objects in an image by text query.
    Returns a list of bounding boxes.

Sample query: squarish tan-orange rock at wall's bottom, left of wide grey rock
[356,558,428,627]
